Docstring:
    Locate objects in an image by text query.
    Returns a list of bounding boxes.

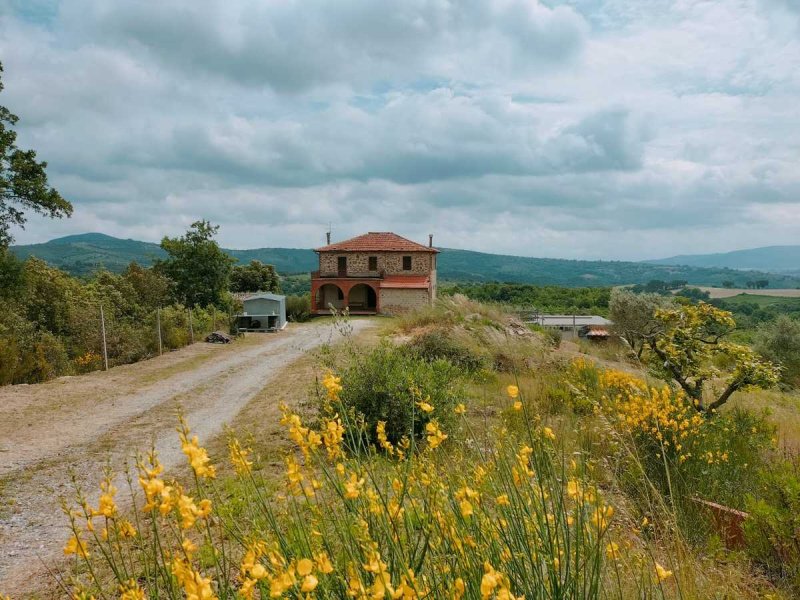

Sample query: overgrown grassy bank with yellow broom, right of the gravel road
[42,296,800,600]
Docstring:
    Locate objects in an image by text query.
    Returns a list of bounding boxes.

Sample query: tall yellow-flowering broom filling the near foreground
[64,404,620,600]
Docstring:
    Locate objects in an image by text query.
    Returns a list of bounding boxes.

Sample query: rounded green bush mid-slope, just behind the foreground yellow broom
[328,343,464,444]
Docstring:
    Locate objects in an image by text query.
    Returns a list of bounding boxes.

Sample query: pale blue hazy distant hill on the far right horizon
[647,246,800,273]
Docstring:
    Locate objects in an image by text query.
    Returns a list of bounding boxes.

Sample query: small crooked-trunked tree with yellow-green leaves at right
[644,302,780,414]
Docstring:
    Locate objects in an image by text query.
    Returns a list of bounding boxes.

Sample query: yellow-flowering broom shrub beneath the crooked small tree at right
[569,359,774,534]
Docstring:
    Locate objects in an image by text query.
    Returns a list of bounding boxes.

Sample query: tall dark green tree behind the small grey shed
[155,221,234,307]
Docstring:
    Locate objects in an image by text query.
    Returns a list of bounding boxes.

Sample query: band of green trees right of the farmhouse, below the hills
[440,283,611,315]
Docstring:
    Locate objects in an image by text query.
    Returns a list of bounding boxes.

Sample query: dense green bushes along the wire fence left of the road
[0,258,225,385]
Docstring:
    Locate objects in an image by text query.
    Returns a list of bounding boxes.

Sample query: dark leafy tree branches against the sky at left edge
[0,63,72,249]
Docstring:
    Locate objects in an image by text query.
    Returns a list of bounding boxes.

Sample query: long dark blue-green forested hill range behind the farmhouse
[12,233,800,288]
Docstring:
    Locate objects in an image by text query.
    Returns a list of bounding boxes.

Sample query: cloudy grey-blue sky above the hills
[0,0,800,259]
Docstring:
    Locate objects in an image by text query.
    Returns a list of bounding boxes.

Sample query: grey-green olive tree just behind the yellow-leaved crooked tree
[608,288,670,358]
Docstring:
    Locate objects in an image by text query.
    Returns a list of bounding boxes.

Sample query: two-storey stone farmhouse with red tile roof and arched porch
[311,232,439,315]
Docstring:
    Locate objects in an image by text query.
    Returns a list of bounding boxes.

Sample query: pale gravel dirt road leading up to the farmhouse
[0,320,372,597]
